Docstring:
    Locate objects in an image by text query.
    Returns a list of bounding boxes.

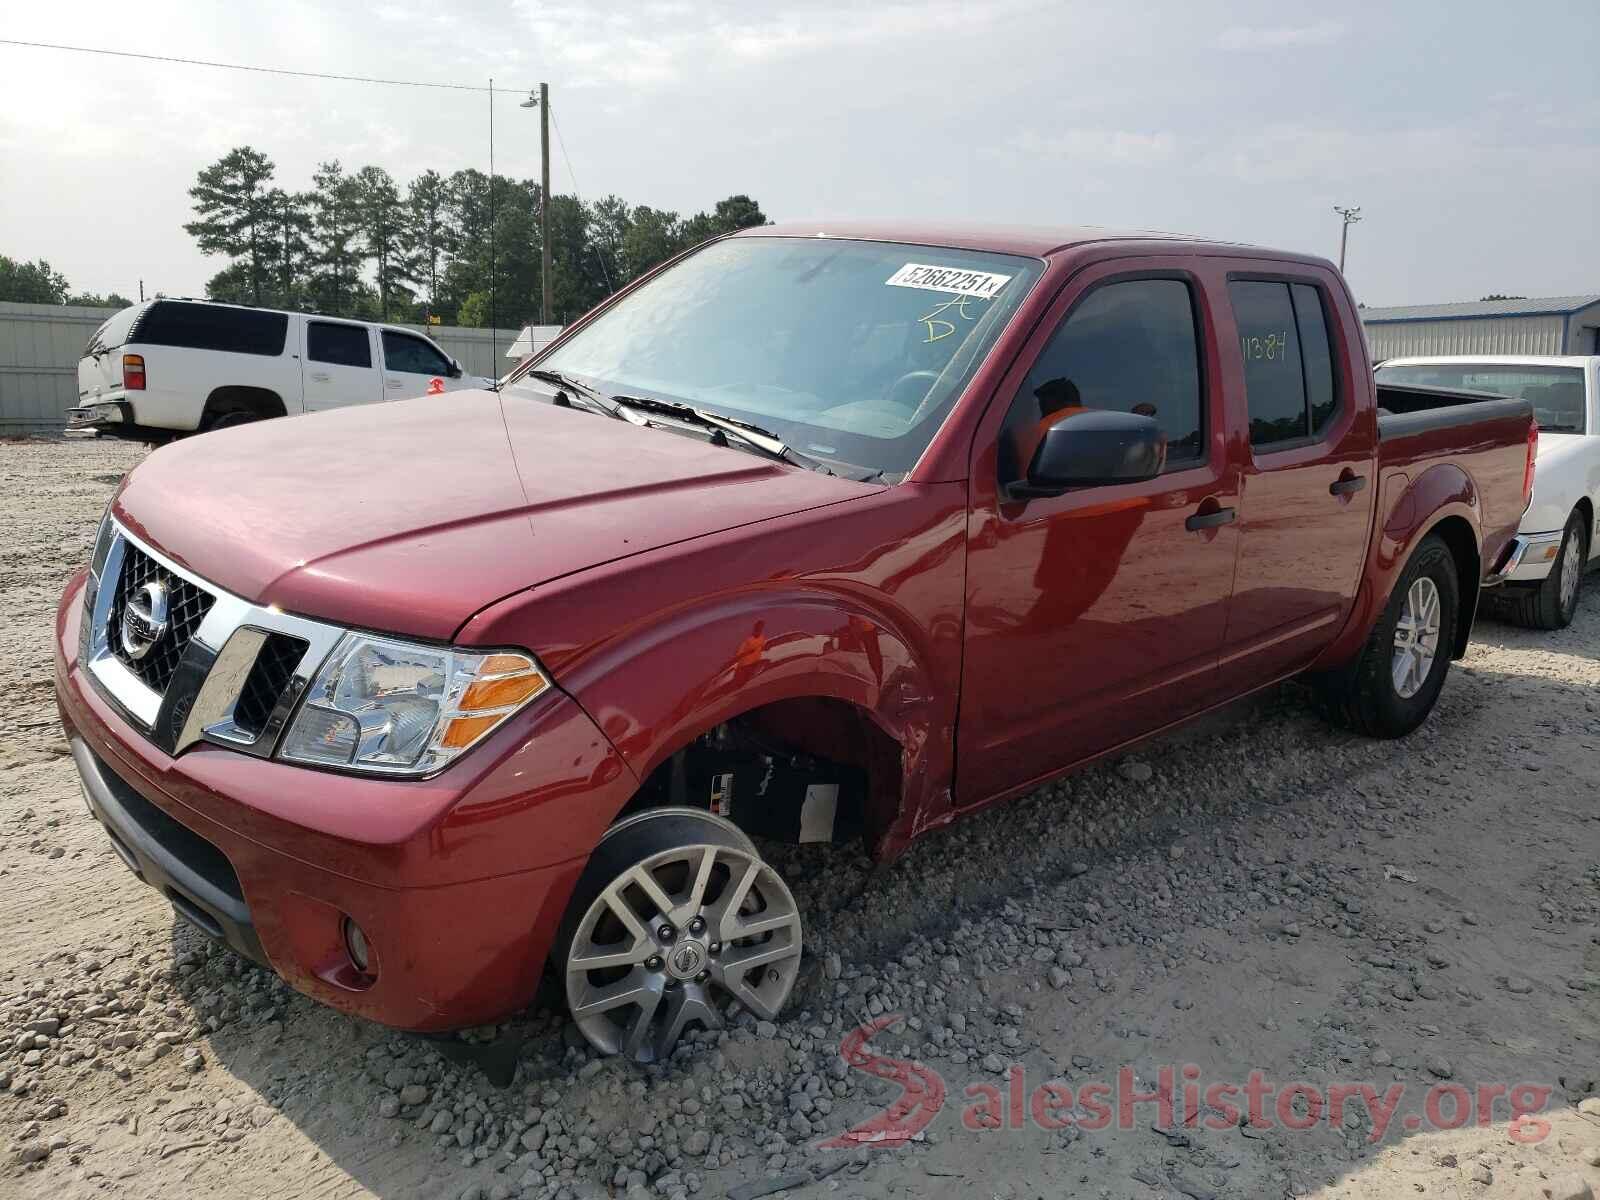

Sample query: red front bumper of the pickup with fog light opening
[54,574,637,1030]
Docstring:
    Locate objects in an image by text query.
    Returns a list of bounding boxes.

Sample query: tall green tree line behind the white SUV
[184,146,766,326]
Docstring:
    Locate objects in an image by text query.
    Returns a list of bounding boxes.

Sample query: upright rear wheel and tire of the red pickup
[1318,534,1461,738]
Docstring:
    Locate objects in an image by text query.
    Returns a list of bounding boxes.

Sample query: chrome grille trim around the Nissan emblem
[83,520,344,758]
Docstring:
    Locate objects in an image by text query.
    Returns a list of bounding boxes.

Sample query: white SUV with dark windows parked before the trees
[67,299,494,442]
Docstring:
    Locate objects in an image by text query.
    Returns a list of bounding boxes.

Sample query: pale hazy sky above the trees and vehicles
[0,0,1600,304]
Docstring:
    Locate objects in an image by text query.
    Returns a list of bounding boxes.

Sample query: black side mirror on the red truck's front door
[1010,408,1166,498]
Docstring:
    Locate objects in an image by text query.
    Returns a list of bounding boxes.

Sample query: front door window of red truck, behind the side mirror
[1000,278,1205,482]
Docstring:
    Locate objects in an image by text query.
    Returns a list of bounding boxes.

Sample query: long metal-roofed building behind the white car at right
[1362,294,1600,358]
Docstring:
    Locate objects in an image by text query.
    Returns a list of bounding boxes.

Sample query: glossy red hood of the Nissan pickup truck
[114,392,878,640]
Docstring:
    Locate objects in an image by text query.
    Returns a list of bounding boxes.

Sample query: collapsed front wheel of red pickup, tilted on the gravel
[552,808,802,1062]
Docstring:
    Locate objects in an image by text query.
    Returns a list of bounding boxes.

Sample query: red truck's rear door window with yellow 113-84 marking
[1227,280,1339,446]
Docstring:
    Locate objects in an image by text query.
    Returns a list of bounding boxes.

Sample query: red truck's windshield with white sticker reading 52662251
[512,237,1043,475]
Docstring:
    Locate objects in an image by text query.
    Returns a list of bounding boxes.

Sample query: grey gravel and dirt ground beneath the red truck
[0,442,1600,1200]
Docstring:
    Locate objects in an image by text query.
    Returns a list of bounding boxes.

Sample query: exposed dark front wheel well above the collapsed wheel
[624,696,901,851]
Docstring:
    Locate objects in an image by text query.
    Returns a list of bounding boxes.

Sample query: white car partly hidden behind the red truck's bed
[1378,354,1600,629]
